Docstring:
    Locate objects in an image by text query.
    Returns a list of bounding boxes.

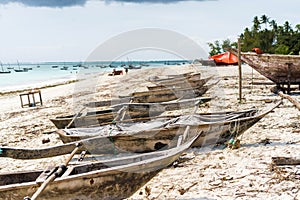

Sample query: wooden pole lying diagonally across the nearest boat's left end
[24,143,80,200]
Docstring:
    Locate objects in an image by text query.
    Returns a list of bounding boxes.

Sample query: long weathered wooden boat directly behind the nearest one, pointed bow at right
[56,101,281,150]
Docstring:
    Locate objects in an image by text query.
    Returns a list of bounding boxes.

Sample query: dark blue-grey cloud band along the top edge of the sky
[0,0,214,8]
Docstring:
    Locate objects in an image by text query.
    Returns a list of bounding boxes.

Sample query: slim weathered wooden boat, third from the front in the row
[50,97,211,129]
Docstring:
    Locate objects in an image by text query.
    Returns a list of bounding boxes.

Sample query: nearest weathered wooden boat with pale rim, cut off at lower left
[0,134,195,200]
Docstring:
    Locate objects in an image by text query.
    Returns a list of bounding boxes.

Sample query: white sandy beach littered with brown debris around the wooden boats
[0,65,300,200]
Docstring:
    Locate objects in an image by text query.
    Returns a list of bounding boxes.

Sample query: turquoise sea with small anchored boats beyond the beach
[0,60,190,93]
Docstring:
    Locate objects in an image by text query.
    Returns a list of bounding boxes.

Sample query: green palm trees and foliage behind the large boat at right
[208,15,300,55]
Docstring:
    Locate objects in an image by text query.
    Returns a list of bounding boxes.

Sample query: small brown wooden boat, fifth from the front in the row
[147,77,212,90]
